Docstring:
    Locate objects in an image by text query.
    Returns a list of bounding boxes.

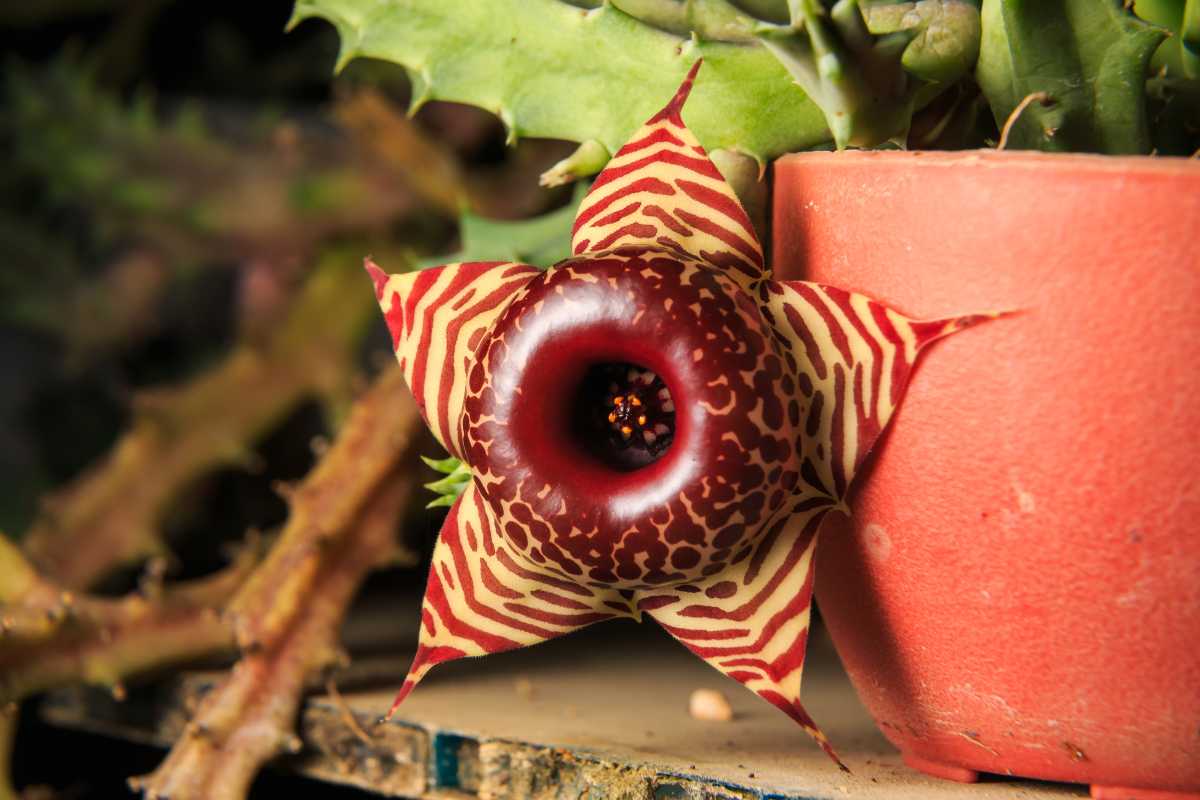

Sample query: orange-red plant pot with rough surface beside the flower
[774,152,1200,798]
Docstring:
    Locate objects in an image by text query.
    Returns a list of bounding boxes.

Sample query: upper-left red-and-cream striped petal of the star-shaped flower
[365,259,541,458]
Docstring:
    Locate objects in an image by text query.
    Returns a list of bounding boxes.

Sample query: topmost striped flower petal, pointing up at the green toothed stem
[571,61,766,291]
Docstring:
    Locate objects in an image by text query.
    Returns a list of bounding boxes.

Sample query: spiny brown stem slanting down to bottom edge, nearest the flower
[131,368,420,800]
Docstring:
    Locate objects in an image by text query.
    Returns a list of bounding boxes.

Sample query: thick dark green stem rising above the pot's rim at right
[976,0,1164,154]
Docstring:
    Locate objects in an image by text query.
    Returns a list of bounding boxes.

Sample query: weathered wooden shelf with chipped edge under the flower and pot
[43,614,1086,800]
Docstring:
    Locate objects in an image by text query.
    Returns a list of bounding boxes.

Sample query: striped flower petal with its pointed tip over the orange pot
[764,281,994,501]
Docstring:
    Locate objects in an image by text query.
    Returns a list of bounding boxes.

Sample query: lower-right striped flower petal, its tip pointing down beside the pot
[636,501,845,769]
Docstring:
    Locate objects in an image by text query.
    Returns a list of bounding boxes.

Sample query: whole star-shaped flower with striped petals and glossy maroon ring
[367,61,980,763]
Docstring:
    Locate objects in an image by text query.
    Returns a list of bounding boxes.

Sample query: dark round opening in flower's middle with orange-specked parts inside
[571,362,676,471]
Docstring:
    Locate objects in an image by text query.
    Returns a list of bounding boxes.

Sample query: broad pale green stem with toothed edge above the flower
[292,0,829,162]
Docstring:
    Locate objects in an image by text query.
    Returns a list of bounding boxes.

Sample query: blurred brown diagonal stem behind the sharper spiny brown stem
[25,251,384,589]
